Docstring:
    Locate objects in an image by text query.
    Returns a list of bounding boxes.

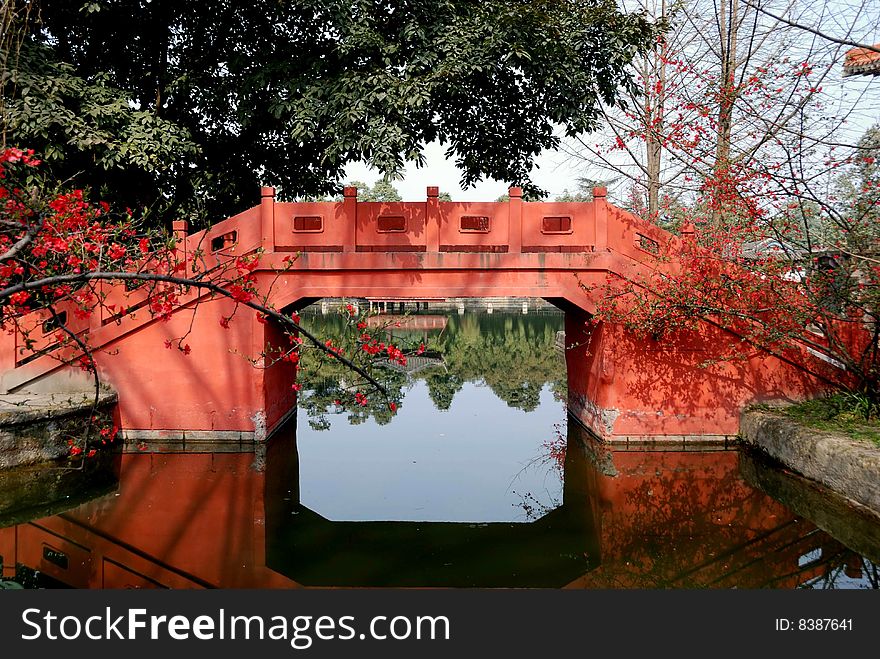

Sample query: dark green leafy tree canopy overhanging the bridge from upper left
[6,0,655,226]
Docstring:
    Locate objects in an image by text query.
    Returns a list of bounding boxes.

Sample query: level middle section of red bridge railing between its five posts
[268,187,608,254]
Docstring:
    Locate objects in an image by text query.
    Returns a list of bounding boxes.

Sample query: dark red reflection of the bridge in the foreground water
[0,422,880,588]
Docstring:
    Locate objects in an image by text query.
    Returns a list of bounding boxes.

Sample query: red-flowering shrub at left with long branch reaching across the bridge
[0,148,420,457]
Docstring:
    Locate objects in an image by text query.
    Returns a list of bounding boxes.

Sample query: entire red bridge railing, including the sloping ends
[0,182,670,382]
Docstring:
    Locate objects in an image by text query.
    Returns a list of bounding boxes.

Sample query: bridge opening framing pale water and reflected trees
[282,298,567,523]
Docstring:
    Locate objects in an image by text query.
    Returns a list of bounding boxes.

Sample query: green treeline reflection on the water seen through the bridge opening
[298,313,566,422]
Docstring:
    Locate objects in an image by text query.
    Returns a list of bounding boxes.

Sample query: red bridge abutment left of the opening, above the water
[59,299,296,452]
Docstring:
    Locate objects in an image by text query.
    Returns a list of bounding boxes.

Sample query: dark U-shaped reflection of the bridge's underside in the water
[266,422,599,588]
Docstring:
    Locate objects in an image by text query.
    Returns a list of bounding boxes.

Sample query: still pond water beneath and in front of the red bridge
[0,312,880,588]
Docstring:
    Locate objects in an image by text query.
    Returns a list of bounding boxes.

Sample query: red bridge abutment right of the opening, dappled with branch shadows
[565,310,828,445]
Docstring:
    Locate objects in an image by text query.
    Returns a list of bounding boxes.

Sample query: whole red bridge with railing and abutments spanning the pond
[0,187,836,450]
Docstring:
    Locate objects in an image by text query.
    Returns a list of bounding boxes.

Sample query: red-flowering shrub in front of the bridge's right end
[593,189,880,399]
